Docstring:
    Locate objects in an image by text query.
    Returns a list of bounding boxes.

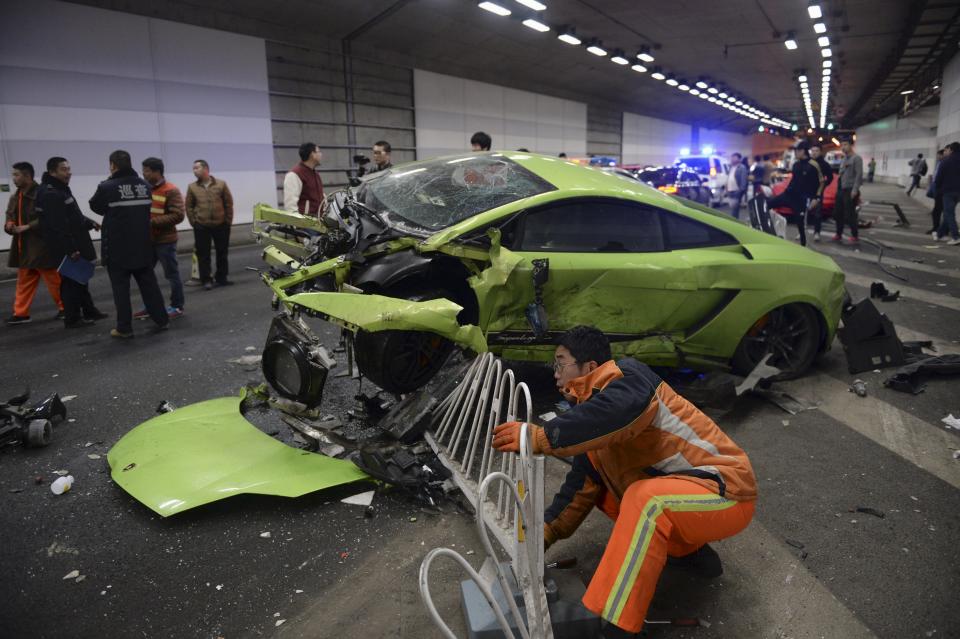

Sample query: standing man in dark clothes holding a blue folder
[36,157,107,328]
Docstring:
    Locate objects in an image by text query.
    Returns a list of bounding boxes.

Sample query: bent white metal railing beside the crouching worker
[420,353,553,639]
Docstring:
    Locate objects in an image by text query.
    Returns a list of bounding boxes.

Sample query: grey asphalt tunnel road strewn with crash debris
[0,185,960,639]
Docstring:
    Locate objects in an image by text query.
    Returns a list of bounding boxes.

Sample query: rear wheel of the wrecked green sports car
[732,304,820,379]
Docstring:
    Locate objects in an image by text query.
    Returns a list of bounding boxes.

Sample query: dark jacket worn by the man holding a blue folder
[36,173,97,266]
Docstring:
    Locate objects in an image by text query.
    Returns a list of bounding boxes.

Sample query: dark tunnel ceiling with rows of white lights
[69,0,960,131]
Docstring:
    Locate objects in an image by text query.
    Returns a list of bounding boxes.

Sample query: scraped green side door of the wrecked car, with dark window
[486,197,697,351]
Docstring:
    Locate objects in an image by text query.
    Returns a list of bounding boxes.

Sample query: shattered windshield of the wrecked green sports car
[357,154,554,231]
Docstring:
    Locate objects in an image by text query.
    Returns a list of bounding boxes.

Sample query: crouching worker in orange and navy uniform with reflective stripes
[492,326,757,637]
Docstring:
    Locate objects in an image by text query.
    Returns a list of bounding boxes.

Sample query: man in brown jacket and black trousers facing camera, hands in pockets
[186,160,234,291]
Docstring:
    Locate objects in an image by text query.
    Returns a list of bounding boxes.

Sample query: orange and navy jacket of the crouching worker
[536,359,757,544]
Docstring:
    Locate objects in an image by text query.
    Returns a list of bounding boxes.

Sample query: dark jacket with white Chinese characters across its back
[90,169,153,270]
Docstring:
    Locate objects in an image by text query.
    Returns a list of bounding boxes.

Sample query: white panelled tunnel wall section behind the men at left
[0,0,273,254]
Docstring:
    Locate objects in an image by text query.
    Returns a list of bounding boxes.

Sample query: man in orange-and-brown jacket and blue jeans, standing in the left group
[140,158,184,319]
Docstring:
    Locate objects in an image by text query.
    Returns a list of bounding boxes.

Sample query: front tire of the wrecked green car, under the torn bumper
[354,291,454,393]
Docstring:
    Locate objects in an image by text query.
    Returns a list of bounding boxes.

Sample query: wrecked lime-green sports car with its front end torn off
[255,152,845,403]
